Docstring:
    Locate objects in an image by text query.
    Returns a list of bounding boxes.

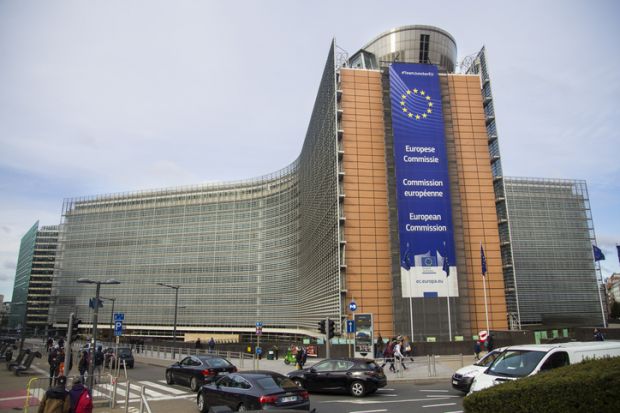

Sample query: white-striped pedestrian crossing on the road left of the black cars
[30,380,196,404]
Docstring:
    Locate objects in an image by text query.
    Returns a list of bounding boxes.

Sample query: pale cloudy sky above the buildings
[0,0,620,301]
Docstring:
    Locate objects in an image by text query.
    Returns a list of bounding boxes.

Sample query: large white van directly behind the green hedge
[469,341,620,393]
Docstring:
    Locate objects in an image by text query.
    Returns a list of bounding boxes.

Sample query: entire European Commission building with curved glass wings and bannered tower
[44,26,600,341]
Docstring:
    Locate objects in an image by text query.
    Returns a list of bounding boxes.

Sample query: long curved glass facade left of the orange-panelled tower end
[50,45,340,334]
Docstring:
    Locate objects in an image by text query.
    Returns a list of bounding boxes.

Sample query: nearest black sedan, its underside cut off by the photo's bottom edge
[196,370,310,413]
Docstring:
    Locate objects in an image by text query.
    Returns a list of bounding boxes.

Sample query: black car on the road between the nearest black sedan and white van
[288,358,387,397]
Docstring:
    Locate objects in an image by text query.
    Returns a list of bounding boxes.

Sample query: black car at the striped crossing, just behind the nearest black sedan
[166,355,237,391]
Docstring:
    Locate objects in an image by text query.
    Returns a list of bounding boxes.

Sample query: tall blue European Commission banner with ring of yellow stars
[390,63,458,297]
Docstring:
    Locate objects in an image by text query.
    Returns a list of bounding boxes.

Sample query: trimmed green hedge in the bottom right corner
[463,357,620,413]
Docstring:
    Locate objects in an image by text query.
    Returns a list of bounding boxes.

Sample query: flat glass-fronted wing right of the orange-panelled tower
[505,177,603,325]
